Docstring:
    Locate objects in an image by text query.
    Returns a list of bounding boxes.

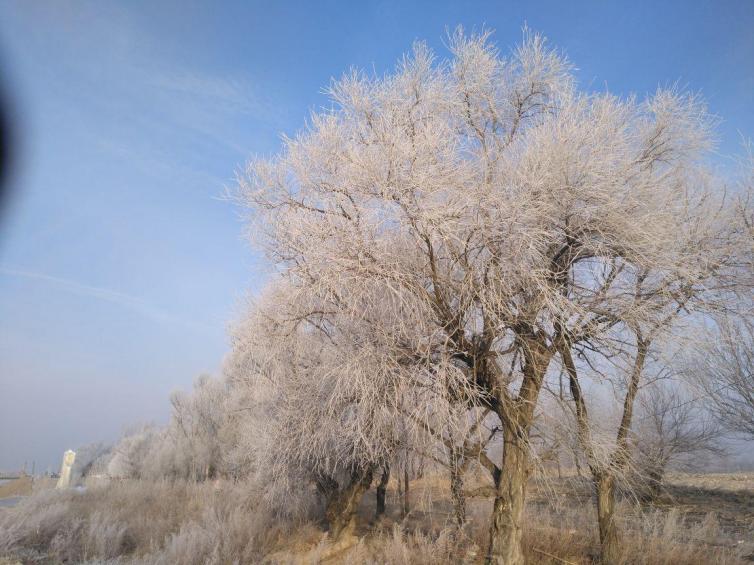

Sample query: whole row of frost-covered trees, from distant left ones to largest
[92,31,752,564]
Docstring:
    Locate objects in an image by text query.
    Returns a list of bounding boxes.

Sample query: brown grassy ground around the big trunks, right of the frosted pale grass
[268,475,754,565]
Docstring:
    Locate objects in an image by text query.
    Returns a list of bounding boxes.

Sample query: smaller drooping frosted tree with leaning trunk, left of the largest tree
[226,283,429,537]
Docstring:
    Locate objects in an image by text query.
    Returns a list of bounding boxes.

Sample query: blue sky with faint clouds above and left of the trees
[0,0,754,469]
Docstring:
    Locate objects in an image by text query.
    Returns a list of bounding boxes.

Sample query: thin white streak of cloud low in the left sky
[0,266,215,332]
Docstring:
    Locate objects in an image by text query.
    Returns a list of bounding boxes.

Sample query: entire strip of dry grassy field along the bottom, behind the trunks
[0,473,754,565]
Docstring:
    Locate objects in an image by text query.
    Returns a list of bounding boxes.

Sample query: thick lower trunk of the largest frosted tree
[486,425,529,565]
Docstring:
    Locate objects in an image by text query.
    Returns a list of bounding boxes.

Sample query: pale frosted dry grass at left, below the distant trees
[0,481,294,565]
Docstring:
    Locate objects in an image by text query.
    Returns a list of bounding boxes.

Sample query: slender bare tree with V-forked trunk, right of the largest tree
[559,312,735,563]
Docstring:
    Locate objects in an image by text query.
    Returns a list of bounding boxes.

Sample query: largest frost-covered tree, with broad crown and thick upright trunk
[239,28,738,564]
